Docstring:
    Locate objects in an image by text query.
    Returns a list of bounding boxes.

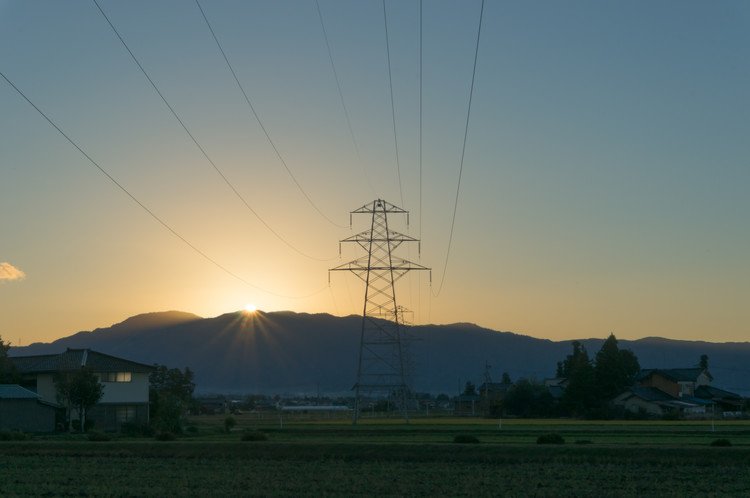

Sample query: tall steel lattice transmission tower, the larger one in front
[329,199,430,424]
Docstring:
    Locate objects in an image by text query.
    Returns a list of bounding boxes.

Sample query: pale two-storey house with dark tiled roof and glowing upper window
[10,349,153,431]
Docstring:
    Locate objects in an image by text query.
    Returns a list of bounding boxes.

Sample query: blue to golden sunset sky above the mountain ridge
[0,0,750,345]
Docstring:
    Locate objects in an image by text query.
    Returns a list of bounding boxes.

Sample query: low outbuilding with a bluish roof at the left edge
[0,384,59,432]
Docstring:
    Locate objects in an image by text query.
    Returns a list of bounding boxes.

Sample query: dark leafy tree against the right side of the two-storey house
[149,365,195,433]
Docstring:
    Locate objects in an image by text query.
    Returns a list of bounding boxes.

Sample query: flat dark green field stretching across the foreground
[0,416,750,496]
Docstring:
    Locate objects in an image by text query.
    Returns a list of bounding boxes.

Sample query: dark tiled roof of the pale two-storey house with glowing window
[10,348,154,374]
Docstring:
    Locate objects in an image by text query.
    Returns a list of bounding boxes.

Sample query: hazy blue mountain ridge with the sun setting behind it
[10,311,750,395]
